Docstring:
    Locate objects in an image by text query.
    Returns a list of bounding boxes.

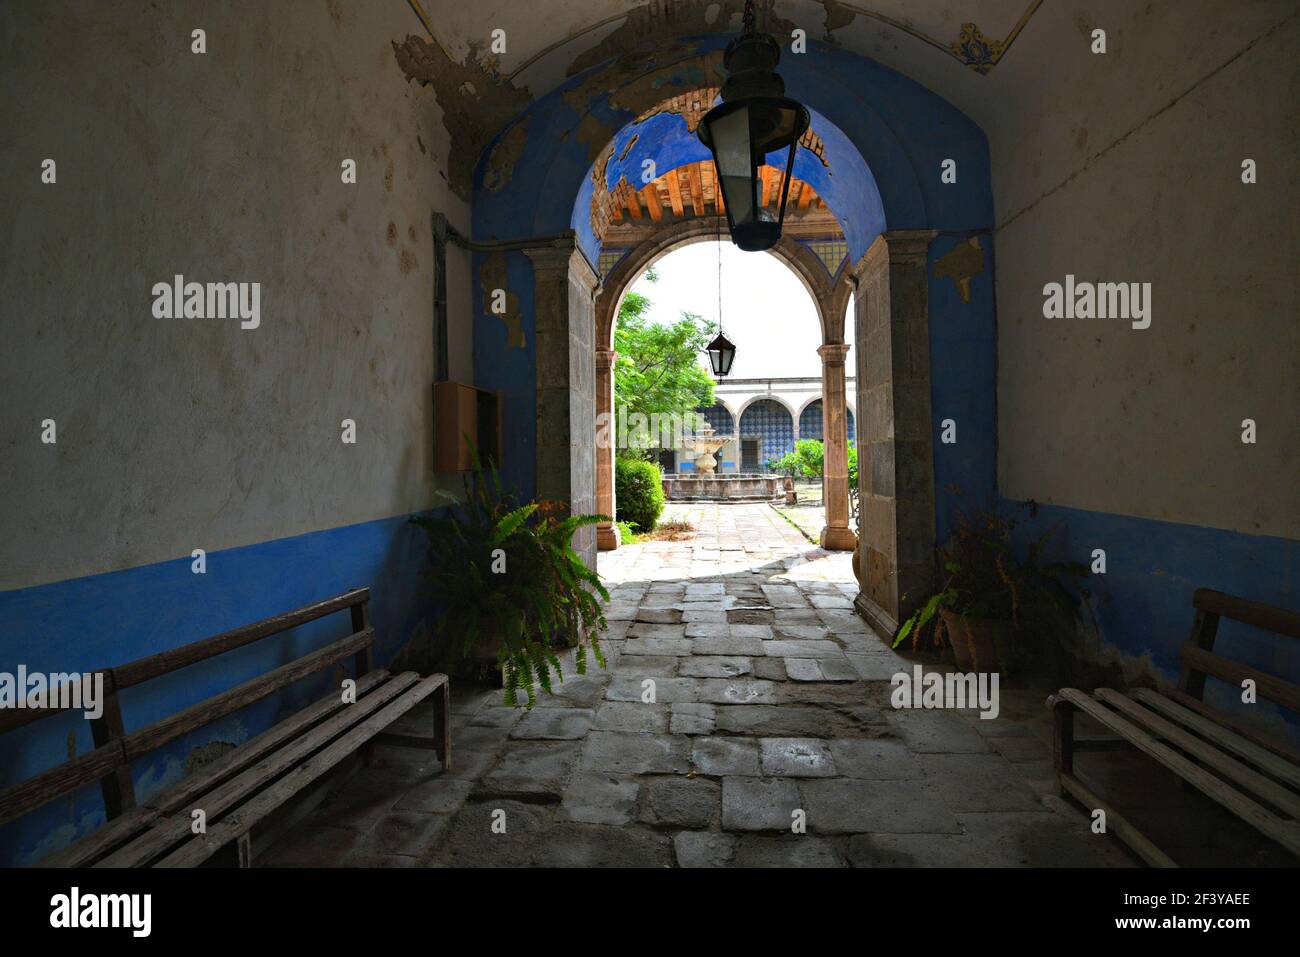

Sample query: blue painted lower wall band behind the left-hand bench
[0,516,432,866]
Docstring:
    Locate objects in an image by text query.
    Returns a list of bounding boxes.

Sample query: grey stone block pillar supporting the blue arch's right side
[854,230,936,635]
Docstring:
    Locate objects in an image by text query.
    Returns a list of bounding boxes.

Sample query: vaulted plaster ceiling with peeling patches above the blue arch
[400,0,1295,239]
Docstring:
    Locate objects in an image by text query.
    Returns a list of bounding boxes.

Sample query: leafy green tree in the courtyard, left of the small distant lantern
[614,280,716,452]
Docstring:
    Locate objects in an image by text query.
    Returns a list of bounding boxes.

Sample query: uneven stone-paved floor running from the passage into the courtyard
[259,505,1130,866]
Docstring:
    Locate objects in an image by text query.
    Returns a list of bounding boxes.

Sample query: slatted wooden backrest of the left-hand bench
[0,588,374,824]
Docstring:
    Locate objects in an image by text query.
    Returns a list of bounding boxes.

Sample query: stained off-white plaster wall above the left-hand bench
[0,0,472,588]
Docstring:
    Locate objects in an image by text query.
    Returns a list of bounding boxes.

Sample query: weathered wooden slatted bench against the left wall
[0,588,451,867]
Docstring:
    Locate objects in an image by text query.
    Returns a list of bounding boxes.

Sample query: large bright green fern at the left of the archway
[411,467,610,707]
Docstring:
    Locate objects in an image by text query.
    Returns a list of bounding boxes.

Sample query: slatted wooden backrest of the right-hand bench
[1178,588,1300,714]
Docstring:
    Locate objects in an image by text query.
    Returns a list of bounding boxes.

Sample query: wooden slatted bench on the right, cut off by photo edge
[1048,588,1300,867]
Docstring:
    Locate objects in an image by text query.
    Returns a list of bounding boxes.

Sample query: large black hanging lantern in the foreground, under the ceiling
[697,0,809,252]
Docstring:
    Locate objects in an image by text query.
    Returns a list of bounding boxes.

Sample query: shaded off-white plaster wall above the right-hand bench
[987,0,1300,538]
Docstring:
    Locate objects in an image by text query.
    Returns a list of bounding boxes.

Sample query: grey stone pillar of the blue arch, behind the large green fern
[525,246,599,568]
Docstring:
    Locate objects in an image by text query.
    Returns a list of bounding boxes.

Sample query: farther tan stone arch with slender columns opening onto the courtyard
[594,217,858,551]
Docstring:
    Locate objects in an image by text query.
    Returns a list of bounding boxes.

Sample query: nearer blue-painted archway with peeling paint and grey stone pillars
[473,44,996,631]
